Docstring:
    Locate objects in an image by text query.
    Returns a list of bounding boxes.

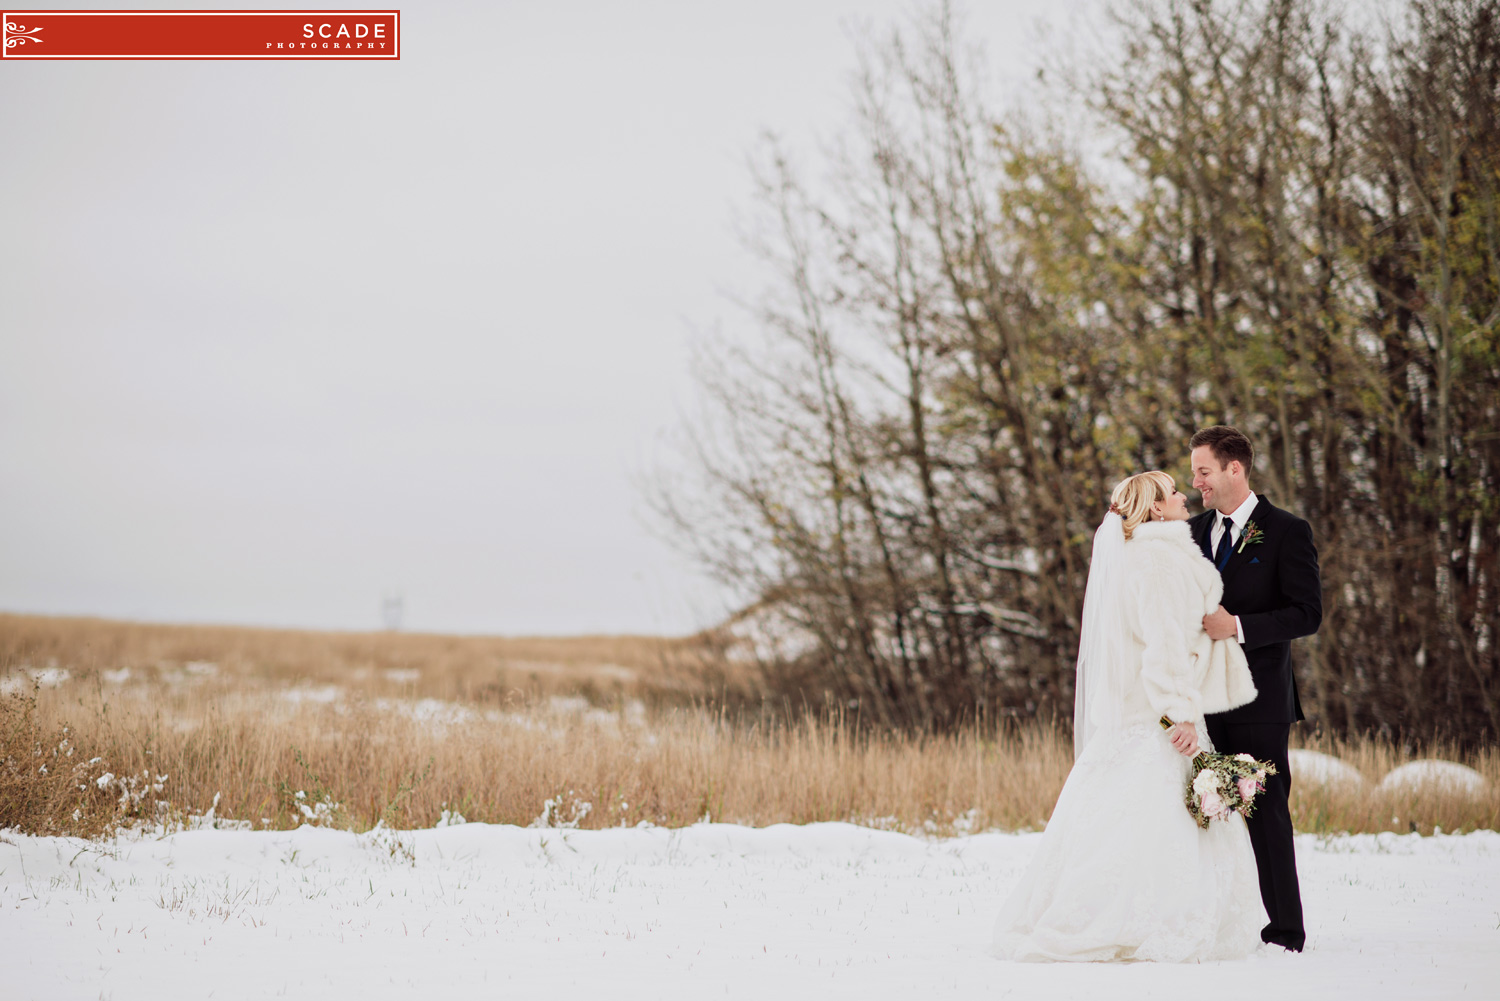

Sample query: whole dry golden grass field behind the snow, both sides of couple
[0,617,1500,833]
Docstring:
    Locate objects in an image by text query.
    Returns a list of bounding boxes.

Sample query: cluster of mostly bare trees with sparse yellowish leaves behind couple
[659,0,1500,735]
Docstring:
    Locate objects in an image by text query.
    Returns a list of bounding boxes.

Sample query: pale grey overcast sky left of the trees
[0,0,1097,633]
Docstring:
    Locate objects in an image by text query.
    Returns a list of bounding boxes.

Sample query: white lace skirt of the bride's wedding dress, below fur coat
[995,722,1266,962]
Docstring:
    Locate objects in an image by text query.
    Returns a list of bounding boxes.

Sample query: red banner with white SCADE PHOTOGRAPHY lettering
[0,11,401,59]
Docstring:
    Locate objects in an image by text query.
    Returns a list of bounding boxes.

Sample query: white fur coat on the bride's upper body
[1125,521,1256,720]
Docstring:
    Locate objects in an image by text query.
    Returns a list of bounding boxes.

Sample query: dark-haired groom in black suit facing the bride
[1188,426,1323,953]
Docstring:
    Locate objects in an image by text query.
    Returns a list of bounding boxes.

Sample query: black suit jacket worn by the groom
[1188,497,1323,723]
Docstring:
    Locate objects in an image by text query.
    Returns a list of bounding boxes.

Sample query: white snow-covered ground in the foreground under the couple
[0,824,1500,1001]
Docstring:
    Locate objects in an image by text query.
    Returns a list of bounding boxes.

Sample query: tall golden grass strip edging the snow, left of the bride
[2,681,1071,831]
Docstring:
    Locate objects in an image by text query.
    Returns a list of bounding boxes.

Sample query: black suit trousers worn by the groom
[1205,716,1307,951]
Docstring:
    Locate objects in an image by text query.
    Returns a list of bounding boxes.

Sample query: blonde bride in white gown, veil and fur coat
[995,471,1265,962]
